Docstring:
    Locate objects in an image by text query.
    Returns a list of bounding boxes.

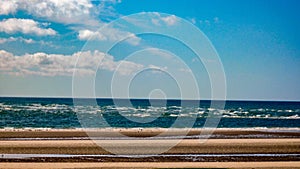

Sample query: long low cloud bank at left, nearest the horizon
[0,50,144,76]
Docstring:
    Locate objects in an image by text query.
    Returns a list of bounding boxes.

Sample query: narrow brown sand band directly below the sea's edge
[0,128,300,139]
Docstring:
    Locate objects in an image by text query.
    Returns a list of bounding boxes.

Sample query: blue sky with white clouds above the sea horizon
[0,0,300,101]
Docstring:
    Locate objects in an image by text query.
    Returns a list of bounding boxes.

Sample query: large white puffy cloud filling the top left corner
[0,0,96,24]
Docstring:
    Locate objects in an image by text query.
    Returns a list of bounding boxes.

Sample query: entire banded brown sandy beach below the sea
[0,128,300,168]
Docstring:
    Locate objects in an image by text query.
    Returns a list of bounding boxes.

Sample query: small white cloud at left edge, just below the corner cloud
[0,18,56,36]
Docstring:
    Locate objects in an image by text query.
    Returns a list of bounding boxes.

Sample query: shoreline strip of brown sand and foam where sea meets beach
[0,128,300,140]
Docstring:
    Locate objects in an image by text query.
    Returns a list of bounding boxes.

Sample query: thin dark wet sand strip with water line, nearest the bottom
[0,154,300,162]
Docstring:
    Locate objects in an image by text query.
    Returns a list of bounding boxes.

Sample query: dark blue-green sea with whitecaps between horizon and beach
[0,97,300,128]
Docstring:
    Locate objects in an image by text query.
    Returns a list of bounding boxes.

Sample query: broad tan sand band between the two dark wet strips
[0,139,300,154]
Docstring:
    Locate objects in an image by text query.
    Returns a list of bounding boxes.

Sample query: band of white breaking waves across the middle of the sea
[0,103,300,119]
